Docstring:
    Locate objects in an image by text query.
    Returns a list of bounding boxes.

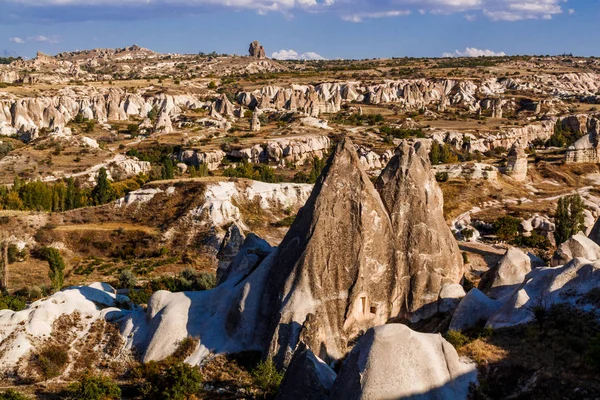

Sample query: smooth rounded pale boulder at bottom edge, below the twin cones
[331,324,477,400]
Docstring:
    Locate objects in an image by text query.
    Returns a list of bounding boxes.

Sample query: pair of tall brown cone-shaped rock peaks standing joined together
[269,139,463,364]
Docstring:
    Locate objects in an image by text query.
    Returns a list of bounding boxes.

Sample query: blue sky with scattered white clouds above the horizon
[0,0,600,59]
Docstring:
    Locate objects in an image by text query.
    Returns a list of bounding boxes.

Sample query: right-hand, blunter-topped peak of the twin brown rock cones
[376,142,463,320]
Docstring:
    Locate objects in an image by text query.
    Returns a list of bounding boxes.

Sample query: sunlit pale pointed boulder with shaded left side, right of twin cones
[479,247,546,299]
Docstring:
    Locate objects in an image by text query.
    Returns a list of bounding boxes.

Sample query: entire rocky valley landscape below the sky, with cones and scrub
[0,42,600,400]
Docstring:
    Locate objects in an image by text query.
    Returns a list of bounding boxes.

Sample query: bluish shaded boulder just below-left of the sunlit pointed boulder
[448,288,503,331]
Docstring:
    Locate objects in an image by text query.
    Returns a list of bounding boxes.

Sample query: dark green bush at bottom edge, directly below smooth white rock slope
[143,363,202,400]
